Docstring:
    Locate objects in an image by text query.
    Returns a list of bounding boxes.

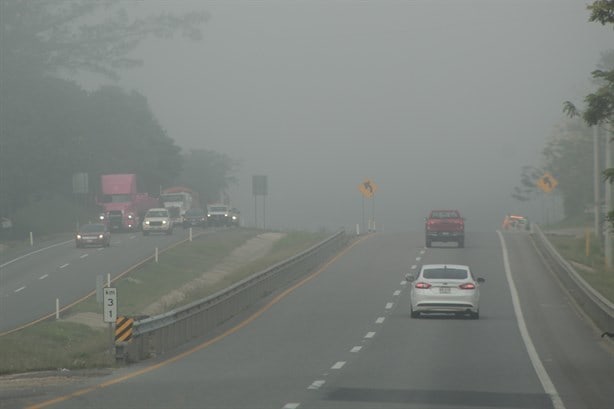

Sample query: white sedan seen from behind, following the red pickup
[406,264,486,319]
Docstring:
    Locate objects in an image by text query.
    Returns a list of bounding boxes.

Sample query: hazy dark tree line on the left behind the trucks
[0,0,234,233]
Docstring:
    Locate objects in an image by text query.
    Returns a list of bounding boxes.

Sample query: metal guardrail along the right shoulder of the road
[531,224,614,332]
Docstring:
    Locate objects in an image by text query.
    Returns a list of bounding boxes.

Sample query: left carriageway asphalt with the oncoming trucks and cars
[0,228,207,333]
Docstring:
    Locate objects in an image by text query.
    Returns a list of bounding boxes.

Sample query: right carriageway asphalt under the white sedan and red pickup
[14,232,614,409]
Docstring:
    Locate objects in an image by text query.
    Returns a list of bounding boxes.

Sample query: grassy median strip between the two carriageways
[0,229,327,374]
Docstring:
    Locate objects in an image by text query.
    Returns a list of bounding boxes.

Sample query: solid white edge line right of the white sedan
[497,230,565,409]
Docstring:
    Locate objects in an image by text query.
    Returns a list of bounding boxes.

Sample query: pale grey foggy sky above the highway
[104,0,614,231]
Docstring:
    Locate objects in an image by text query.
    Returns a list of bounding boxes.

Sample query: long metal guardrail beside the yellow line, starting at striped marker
[116,230,348,362]
